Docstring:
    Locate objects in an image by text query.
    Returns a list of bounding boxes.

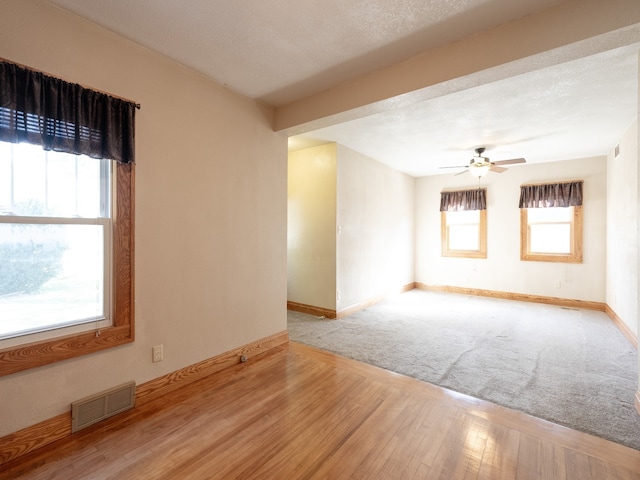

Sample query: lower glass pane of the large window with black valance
[0,223,105,338]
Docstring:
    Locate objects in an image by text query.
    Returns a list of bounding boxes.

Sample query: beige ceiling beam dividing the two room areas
[275,0,640,135]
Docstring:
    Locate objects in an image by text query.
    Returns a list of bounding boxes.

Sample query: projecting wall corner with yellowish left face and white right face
[287,143,415,312]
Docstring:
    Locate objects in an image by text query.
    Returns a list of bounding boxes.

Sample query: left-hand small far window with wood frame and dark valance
[440,190,487,258]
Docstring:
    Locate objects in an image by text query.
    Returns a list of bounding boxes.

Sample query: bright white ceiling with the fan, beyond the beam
[294,44,640,176]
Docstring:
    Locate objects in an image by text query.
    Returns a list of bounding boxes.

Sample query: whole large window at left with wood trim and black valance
[0,61,137,375]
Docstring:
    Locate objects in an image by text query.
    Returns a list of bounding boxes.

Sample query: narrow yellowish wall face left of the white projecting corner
[287,143,337,310]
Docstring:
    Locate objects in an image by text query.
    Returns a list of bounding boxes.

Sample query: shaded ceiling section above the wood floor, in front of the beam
[50,0,560,105]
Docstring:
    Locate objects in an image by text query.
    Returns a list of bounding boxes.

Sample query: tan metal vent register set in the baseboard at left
[71,382,136,433]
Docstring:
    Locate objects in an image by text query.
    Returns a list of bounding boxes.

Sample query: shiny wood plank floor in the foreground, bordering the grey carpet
[0,342,640,480]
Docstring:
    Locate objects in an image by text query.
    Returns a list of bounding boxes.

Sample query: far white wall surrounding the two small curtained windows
[416,157,606,302]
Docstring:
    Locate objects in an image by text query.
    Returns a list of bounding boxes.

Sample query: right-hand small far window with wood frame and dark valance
[520,182,582,263]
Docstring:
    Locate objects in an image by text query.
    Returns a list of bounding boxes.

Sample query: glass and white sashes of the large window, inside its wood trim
[0,142,112,347]
